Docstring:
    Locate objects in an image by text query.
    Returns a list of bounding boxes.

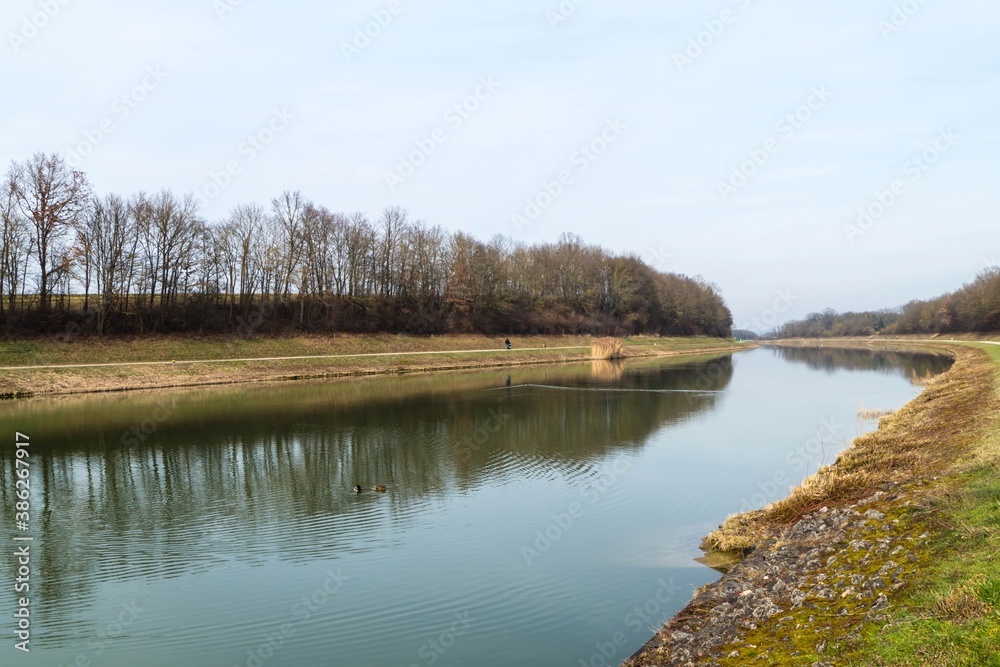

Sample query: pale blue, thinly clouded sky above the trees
[0,0,1000,330]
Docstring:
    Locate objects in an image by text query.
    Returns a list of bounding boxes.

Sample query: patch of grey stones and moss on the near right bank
[624,484,928,667]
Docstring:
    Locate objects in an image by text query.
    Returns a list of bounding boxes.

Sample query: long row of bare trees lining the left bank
[0,153,732,336]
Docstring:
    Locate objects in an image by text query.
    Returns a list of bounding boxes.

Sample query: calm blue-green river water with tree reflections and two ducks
[0,349,947,667]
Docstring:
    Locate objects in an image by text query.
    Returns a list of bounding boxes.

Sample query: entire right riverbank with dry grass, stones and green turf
[625,340,1000,667]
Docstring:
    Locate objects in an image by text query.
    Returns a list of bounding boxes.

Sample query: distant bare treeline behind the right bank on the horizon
[771,267,1000,338]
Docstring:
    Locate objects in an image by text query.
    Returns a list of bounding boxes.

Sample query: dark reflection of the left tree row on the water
[0,357,733,640]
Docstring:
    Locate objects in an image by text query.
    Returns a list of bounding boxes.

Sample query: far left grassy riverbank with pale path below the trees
[0,334,752,398]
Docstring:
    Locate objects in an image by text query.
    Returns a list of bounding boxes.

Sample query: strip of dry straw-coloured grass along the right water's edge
[702,348,997,551]
